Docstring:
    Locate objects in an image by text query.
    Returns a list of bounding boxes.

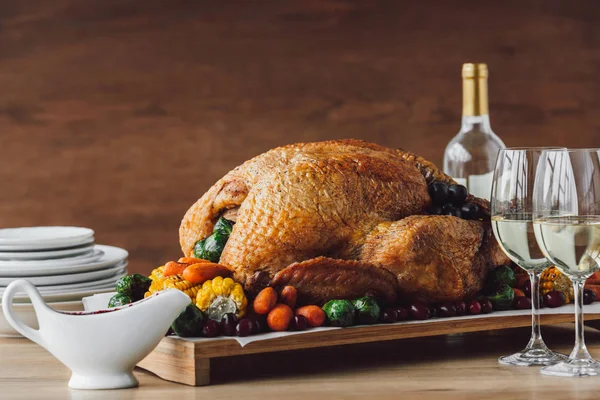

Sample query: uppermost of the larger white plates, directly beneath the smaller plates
[0,245,129,279]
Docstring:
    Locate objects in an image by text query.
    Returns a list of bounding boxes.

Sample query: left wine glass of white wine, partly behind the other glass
[491,147,567,366]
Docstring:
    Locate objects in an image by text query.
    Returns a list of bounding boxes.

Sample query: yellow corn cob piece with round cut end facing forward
[196,276,248,321]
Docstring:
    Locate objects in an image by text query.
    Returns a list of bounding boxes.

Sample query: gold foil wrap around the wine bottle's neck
[462,63,489,117]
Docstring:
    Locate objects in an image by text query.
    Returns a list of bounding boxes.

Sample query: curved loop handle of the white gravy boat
[2,279,48,346]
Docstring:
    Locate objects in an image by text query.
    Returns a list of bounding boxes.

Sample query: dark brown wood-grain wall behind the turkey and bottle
[0,0,600,272]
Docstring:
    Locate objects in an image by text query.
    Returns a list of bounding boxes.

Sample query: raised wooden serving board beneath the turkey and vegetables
[138,312,600,386]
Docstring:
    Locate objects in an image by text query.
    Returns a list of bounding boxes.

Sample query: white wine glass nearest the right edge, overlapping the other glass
[533,149,600,376]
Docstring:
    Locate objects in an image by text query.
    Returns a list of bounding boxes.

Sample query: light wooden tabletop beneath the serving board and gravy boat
[0,324,600,400]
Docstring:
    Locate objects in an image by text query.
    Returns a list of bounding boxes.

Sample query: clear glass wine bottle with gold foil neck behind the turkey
[444,63,506,200]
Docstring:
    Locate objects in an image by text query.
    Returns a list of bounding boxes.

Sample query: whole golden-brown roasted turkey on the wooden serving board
[179,140,508,304]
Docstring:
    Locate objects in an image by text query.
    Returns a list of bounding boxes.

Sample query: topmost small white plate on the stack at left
[0,226,94,251]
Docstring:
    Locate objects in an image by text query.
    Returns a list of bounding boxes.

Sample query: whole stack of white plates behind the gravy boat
[0,226,128,336]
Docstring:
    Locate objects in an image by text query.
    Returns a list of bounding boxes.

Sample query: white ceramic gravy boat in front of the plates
[2,279,190,389]
